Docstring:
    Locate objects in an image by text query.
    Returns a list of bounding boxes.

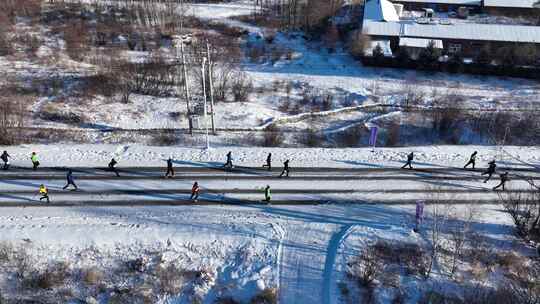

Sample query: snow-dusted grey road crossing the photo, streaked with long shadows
[0,164,540,206]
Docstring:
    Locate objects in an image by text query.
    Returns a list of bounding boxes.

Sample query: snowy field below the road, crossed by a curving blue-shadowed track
[0,205,524,304]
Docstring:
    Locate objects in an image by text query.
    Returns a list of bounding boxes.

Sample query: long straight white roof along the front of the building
[363,20,540,43]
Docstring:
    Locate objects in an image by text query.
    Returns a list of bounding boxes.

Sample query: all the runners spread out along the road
[0,151,509,203]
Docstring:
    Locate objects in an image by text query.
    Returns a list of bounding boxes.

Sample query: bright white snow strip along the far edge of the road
[0,144,540,168]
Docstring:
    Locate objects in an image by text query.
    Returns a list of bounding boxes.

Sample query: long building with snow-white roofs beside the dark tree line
[362,0,540,57]
